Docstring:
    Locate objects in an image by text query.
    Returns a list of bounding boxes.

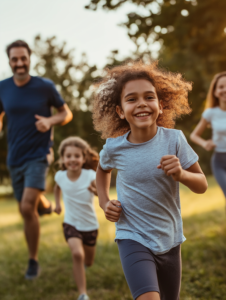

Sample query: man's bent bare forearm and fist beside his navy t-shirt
[35,104,73,132]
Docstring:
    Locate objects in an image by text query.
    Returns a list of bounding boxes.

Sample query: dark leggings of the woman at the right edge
[211,152,226,198]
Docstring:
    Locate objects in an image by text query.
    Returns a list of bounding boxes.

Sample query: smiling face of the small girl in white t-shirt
[62,146,85,172]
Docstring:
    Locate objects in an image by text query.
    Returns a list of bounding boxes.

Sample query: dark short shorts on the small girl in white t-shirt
[63,223,98,246]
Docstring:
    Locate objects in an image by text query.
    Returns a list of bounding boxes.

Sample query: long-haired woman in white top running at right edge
[190,72,226,206]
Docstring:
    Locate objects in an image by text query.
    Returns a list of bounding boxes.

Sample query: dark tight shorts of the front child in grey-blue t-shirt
[117,240,181,300]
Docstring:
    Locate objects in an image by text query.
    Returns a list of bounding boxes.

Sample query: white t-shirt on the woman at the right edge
[202,106,226,152]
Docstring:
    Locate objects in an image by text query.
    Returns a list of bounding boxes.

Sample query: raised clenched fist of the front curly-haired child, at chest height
[157,155,183,181]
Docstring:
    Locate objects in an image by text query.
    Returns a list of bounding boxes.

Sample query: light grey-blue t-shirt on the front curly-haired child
[100,127,198,254]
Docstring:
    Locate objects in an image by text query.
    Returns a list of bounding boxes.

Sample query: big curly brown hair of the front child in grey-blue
[93,60,192,139]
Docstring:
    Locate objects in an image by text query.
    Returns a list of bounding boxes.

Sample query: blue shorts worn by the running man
[8,157,48,202]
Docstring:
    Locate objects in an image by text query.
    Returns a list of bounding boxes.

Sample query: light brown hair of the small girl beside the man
[57,136,99,171]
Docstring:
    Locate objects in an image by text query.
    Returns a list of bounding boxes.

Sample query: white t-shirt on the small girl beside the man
[55,169,99,231]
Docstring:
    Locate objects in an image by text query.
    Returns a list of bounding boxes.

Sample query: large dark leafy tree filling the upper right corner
[86,0,226,173]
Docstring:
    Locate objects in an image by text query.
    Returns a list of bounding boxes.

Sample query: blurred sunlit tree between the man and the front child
[34,35,103,162]
